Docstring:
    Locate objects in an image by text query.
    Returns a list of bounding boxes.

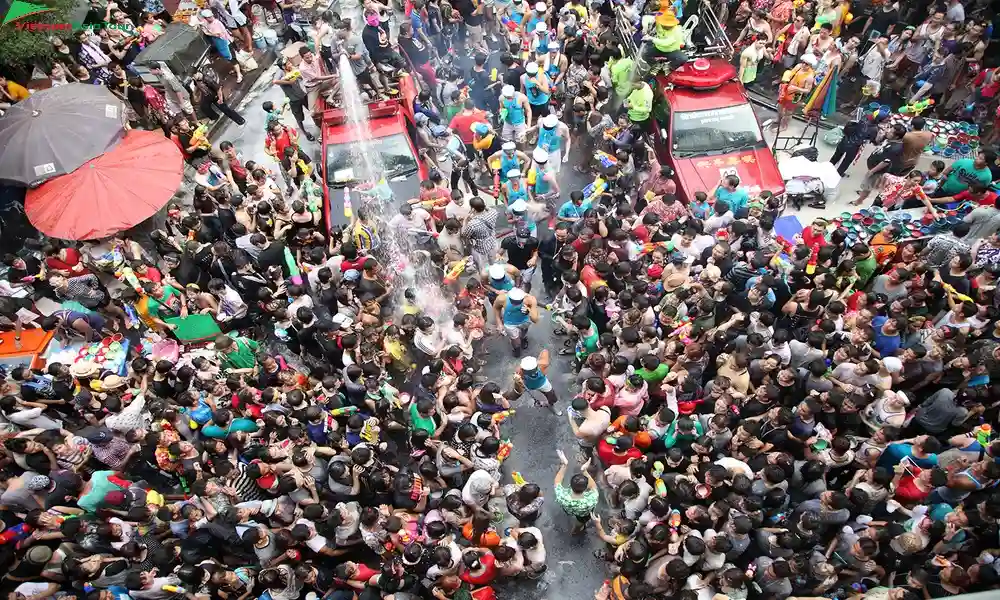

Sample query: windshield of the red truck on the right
[671,104,764,157]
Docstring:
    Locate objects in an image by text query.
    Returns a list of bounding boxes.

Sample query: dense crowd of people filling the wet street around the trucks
[0,0,1000,600]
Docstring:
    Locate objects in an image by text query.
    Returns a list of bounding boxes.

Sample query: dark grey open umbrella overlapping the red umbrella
[0,83,125,186]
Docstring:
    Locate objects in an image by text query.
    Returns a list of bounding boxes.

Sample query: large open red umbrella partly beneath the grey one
[24,130,184,240]
